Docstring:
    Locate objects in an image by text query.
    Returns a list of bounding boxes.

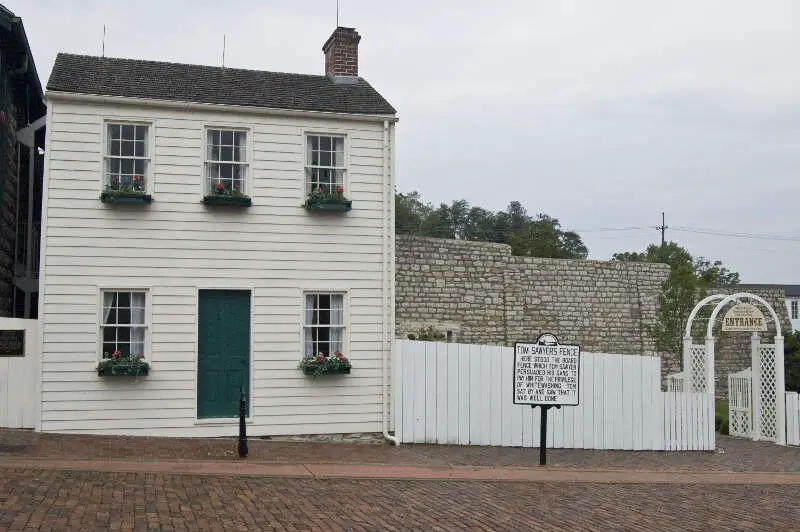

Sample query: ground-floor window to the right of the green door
[303,293,344,357]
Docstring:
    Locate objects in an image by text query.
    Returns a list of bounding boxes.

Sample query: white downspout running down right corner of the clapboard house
[381,120,400,445]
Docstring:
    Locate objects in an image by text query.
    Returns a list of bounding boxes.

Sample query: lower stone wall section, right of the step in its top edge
[505,257,669,355]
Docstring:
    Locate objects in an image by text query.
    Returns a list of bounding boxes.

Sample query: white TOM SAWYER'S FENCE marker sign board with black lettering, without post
[514,333,581,406]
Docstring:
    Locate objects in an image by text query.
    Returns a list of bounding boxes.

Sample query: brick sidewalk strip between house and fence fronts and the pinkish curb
[0,429,800,472]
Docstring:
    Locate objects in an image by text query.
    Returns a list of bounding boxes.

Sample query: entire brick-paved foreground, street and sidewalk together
[0,430,800,532]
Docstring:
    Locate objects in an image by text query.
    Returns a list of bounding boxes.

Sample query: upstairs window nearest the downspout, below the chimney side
[306,135,346,194]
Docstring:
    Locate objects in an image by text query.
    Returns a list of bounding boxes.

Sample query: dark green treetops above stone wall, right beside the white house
[395,191,589,259]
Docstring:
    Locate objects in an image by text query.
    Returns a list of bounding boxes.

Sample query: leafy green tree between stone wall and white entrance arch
[612,242,739,354]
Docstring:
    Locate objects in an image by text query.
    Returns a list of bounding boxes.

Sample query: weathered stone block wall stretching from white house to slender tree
[395,236,669,354]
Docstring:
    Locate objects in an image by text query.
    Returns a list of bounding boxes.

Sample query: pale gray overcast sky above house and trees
[14,0,800,284]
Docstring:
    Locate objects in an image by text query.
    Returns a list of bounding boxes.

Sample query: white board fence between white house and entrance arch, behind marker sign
[393,340,715,451]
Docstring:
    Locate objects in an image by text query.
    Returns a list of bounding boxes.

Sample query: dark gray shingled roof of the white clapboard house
[47,53,395,115]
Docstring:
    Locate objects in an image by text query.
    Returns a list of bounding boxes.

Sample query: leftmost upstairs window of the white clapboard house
[103,123,150,194]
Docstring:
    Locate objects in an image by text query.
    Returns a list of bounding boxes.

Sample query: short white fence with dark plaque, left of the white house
[0,318,41,429]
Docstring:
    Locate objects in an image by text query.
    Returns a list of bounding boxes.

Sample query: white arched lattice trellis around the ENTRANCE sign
[681,292,786,445]
